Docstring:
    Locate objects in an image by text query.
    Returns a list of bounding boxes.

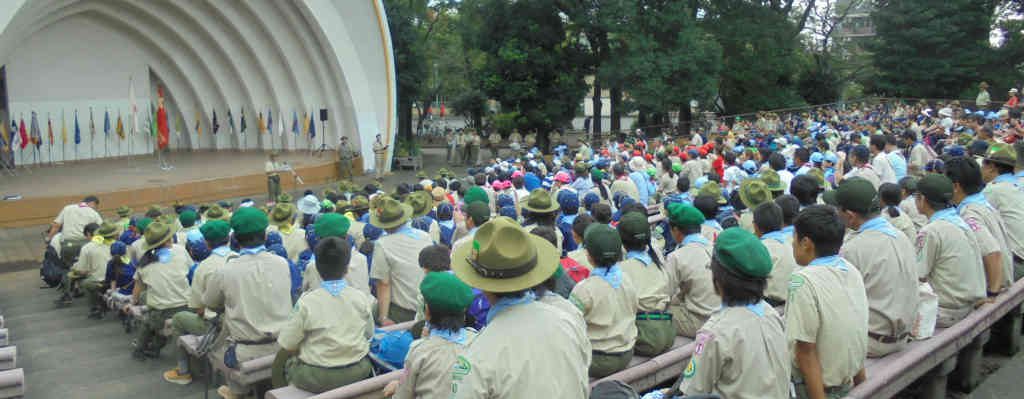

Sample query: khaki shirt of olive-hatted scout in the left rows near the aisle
[135,245,195,310]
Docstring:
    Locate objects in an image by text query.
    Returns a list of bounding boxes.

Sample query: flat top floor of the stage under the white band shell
[0,151,327,200]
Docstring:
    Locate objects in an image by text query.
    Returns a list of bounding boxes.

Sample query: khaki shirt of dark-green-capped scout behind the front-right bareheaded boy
[840,220,918,337]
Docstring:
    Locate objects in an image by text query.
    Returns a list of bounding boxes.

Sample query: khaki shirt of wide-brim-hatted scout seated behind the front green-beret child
[370,223,433,312]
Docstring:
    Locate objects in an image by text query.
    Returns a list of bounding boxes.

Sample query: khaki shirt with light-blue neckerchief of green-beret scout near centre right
[665,234,722,337]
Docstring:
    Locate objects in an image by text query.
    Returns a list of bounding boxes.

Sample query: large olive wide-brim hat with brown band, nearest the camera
[452,217,561,293]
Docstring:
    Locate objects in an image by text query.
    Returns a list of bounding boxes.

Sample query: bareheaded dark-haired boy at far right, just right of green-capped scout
[945,157,1019,297]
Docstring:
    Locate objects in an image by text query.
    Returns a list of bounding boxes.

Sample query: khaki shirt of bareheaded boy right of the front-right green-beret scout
[785,256,868,389]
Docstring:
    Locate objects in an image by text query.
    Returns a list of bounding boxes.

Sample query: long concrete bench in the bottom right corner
[847,280,1024,399]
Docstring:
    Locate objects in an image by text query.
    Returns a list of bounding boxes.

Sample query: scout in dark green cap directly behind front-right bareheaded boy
[836,179,918,357]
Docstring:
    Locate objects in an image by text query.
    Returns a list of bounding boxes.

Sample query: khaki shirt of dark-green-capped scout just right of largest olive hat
[569,272,640,353]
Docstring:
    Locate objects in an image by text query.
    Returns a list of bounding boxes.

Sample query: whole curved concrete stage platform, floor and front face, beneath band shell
[0,151,362,227]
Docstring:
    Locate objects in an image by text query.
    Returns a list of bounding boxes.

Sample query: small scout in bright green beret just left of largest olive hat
[384,271,476,399]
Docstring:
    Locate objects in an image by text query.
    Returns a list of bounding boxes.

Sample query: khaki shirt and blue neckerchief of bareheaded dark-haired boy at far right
[956,193,1022,287]
